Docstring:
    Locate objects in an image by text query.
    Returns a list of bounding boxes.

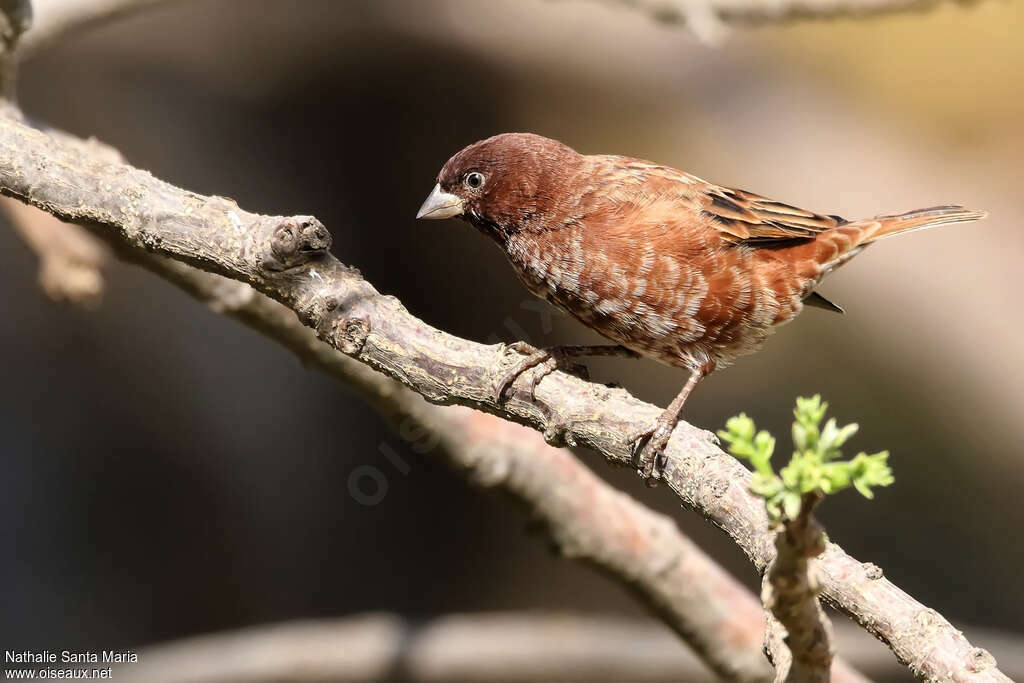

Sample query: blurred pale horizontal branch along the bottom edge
[101,612,1007,683]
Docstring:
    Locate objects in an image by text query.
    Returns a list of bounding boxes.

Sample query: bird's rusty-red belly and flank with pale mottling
[497,228,806,368]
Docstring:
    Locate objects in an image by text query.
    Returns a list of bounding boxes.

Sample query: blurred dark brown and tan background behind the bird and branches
[0,0,1024,679]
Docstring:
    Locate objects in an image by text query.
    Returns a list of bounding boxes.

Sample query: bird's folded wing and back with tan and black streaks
[599,157,847,246]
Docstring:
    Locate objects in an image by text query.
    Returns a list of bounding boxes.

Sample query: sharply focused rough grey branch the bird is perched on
[0,117,1009,681]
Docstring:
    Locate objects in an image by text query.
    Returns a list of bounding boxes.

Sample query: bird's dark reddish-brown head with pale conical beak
[416,133,583,234]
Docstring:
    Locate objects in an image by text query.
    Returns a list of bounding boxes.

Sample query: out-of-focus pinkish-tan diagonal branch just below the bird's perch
[3,198,778,683]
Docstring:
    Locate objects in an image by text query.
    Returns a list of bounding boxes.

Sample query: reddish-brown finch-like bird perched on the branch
[416,133,986,483]
